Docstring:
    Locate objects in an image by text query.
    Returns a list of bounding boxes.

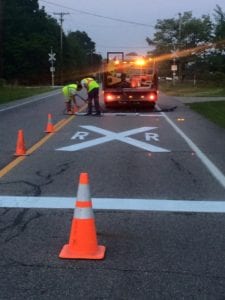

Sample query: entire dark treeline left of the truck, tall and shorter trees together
[0,0,102,84]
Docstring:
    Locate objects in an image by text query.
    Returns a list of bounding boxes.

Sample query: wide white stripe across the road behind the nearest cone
[0,196,225,213]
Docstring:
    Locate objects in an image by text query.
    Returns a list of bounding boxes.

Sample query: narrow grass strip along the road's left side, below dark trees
[0,86,56,104]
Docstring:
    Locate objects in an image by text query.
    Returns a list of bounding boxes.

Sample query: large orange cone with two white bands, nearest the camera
[59,173,106,259]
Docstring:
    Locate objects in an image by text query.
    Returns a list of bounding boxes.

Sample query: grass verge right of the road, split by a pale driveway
[160,82,225,128]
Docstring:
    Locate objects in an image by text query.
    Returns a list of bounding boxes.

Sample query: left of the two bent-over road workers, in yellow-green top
[62,83,82,114]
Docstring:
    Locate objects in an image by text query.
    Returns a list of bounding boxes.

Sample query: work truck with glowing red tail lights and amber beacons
[103,52,158,107]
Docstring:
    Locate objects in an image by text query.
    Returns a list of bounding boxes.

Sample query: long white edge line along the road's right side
[158,106,225,188]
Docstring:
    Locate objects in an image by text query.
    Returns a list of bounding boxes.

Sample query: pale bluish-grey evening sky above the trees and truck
[39,0,225,57]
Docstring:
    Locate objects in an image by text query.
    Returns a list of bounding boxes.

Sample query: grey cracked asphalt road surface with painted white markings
[0,90,225,299]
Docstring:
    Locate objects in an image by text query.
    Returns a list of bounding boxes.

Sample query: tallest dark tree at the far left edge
[3,0,62,83]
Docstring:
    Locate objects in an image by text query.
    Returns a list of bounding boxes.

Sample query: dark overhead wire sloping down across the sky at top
[40,0,155,28]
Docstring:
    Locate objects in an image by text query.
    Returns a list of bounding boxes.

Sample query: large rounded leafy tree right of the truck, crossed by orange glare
[146,12,213,79]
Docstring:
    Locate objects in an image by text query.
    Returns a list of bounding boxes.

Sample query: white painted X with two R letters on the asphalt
[56,126,170,152]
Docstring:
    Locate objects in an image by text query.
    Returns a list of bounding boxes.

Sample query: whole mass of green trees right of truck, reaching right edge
[146,5,225,84]
